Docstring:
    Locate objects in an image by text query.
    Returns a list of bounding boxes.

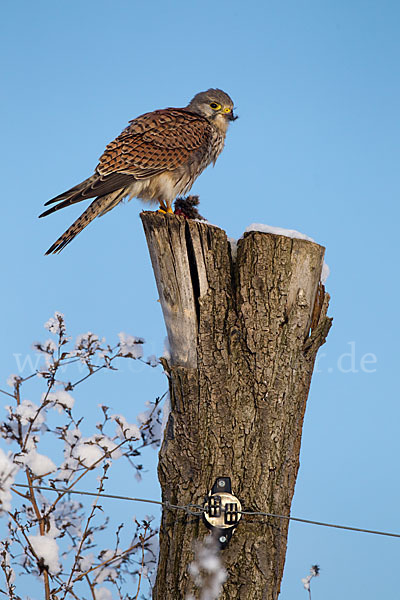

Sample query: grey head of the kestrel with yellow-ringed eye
[187,88,237,131]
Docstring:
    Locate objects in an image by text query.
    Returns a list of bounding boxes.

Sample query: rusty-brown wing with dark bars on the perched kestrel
[96,108,211,179]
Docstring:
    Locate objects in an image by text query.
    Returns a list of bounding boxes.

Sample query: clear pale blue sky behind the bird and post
[0,0,400,600]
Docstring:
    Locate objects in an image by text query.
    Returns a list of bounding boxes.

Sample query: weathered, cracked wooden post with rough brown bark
[142,212,331,600]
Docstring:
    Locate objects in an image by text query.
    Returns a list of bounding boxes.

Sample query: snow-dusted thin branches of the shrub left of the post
[0,313,163,600]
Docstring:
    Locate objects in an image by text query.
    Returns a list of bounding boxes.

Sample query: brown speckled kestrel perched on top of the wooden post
[40,89,237,254]
